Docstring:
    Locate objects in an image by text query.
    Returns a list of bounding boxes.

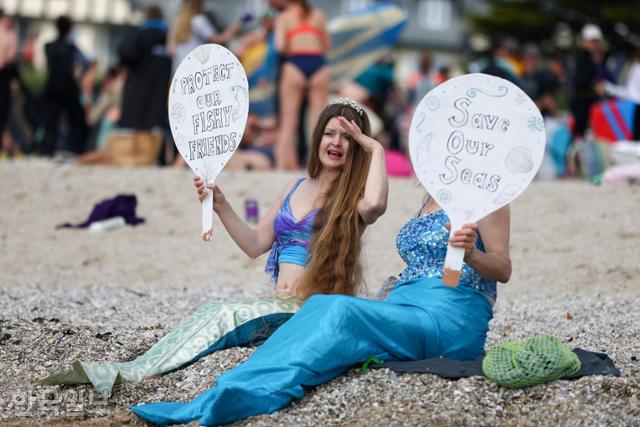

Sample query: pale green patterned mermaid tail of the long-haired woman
[41,296,302,396]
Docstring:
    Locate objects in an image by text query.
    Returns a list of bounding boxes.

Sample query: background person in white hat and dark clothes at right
[570,24,603,140]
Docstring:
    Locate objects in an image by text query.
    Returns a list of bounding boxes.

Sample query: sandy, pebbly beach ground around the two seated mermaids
[0,160,640,425]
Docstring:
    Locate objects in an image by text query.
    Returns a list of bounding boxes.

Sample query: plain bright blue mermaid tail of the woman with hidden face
[132,278,493,426]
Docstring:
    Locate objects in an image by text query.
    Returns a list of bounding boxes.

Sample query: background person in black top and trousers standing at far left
[40,16,89,156]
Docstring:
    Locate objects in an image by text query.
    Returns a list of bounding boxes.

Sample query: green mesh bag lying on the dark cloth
[482,335,580,387]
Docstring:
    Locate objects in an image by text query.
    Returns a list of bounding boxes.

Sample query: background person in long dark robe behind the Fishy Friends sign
[118,6,171,131]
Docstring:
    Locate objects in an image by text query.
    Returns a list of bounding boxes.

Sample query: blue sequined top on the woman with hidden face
[396,209,497,301]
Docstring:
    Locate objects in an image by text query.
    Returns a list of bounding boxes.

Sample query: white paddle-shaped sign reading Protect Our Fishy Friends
[169,44,249,241]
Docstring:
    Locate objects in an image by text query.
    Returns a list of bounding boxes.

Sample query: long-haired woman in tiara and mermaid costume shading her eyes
[43,100,388,394]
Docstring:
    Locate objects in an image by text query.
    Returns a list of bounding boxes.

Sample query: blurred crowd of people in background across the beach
[0,0,640,175]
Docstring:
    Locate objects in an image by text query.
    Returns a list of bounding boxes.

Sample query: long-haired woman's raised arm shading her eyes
[338,117,389,225]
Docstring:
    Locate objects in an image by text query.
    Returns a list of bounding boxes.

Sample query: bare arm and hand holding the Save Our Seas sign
[450,205,511,283]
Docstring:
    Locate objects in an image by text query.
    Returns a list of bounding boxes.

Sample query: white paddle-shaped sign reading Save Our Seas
[409,74,546,285]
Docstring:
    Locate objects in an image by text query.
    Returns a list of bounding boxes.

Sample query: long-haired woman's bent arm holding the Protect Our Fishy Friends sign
[194,176,293,258]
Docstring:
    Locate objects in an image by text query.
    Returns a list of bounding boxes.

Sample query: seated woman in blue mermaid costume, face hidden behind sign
[132,197,511,426]
